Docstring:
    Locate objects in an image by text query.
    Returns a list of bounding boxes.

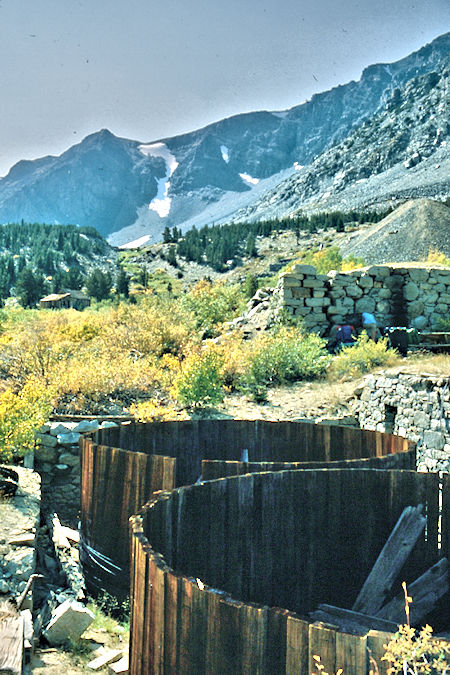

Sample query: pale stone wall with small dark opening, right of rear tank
[358,373,450,472]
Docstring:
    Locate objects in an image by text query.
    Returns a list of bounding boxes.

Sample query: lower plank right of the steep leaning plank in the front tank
[373,558,449,630]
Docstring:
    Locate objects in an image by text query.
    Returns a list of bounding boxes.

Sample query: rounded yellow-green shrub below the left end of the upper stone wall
[240,326,330,400]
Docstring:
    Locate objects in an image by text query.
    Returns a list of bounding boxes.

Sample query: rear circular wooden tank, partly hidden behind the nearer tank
[80,420,415,597]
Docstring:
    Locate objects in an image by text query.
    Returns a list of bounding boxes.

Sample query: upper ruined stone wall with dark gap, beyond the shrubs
[274,265,450,335]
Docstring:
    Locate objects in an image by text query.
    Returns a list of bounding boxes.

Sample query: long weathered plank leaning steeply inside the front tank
[352,504,426,615]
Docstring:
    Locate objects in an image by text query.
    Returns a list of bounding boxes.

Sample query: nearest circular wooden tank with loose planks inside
[130,468,450,675]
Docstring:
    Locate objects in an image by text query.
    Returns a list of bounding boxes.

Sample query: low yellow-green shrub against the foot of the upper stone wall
[330,331,398,377]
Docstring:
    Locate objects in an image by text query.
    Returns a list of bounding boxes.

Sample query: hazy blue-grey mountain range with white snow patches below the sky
[0,34,450,243]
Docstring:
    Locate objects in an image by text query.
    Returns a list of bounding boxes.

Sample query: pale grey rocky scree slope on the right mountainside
[234,67,450,220]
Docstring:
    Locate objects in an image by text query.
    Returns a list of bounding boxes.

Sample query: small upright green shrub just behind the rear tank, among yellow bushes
[174,349,224,408]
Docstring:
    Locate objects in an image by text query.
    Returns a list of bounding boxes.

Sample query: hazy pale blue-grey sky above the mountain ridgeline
[0,0,450,175]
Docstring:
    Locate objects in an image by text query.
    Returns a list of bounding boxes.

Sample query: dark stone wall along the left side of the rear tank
[34,420,117,527]
